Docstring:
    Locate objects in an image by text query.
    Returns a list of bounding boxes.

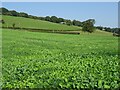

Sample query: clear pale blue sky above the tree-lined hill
[2,2,118,27]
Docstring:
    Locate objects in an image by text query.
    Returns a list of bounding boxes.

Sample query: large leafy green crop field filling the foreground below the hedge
[2,28,120,89]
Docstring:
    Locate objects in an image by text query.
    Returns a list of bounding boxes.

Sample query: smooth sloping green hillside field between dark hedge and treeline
[2,15,81,30]
